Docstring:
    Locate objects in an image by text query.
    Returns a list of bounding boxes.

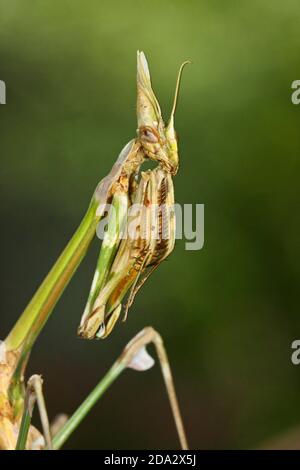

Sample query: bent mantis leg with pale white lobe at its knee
[53,327,188,450]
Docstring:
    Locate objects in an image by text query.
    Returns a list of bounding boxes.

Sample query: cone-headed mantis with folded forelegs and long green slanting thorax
[0,52,187,449]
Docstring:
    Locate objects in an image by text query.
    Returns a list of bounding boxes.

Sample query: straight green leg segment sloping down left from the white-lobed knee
[53,361,125,450]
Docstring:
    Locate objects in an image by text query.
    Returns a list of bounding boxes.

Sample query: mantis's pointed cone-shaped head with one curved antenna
[137,51,190,175]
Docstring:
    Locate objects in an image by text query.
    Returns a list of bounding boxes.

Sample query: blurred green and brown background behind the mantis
[0,0,300,449]
